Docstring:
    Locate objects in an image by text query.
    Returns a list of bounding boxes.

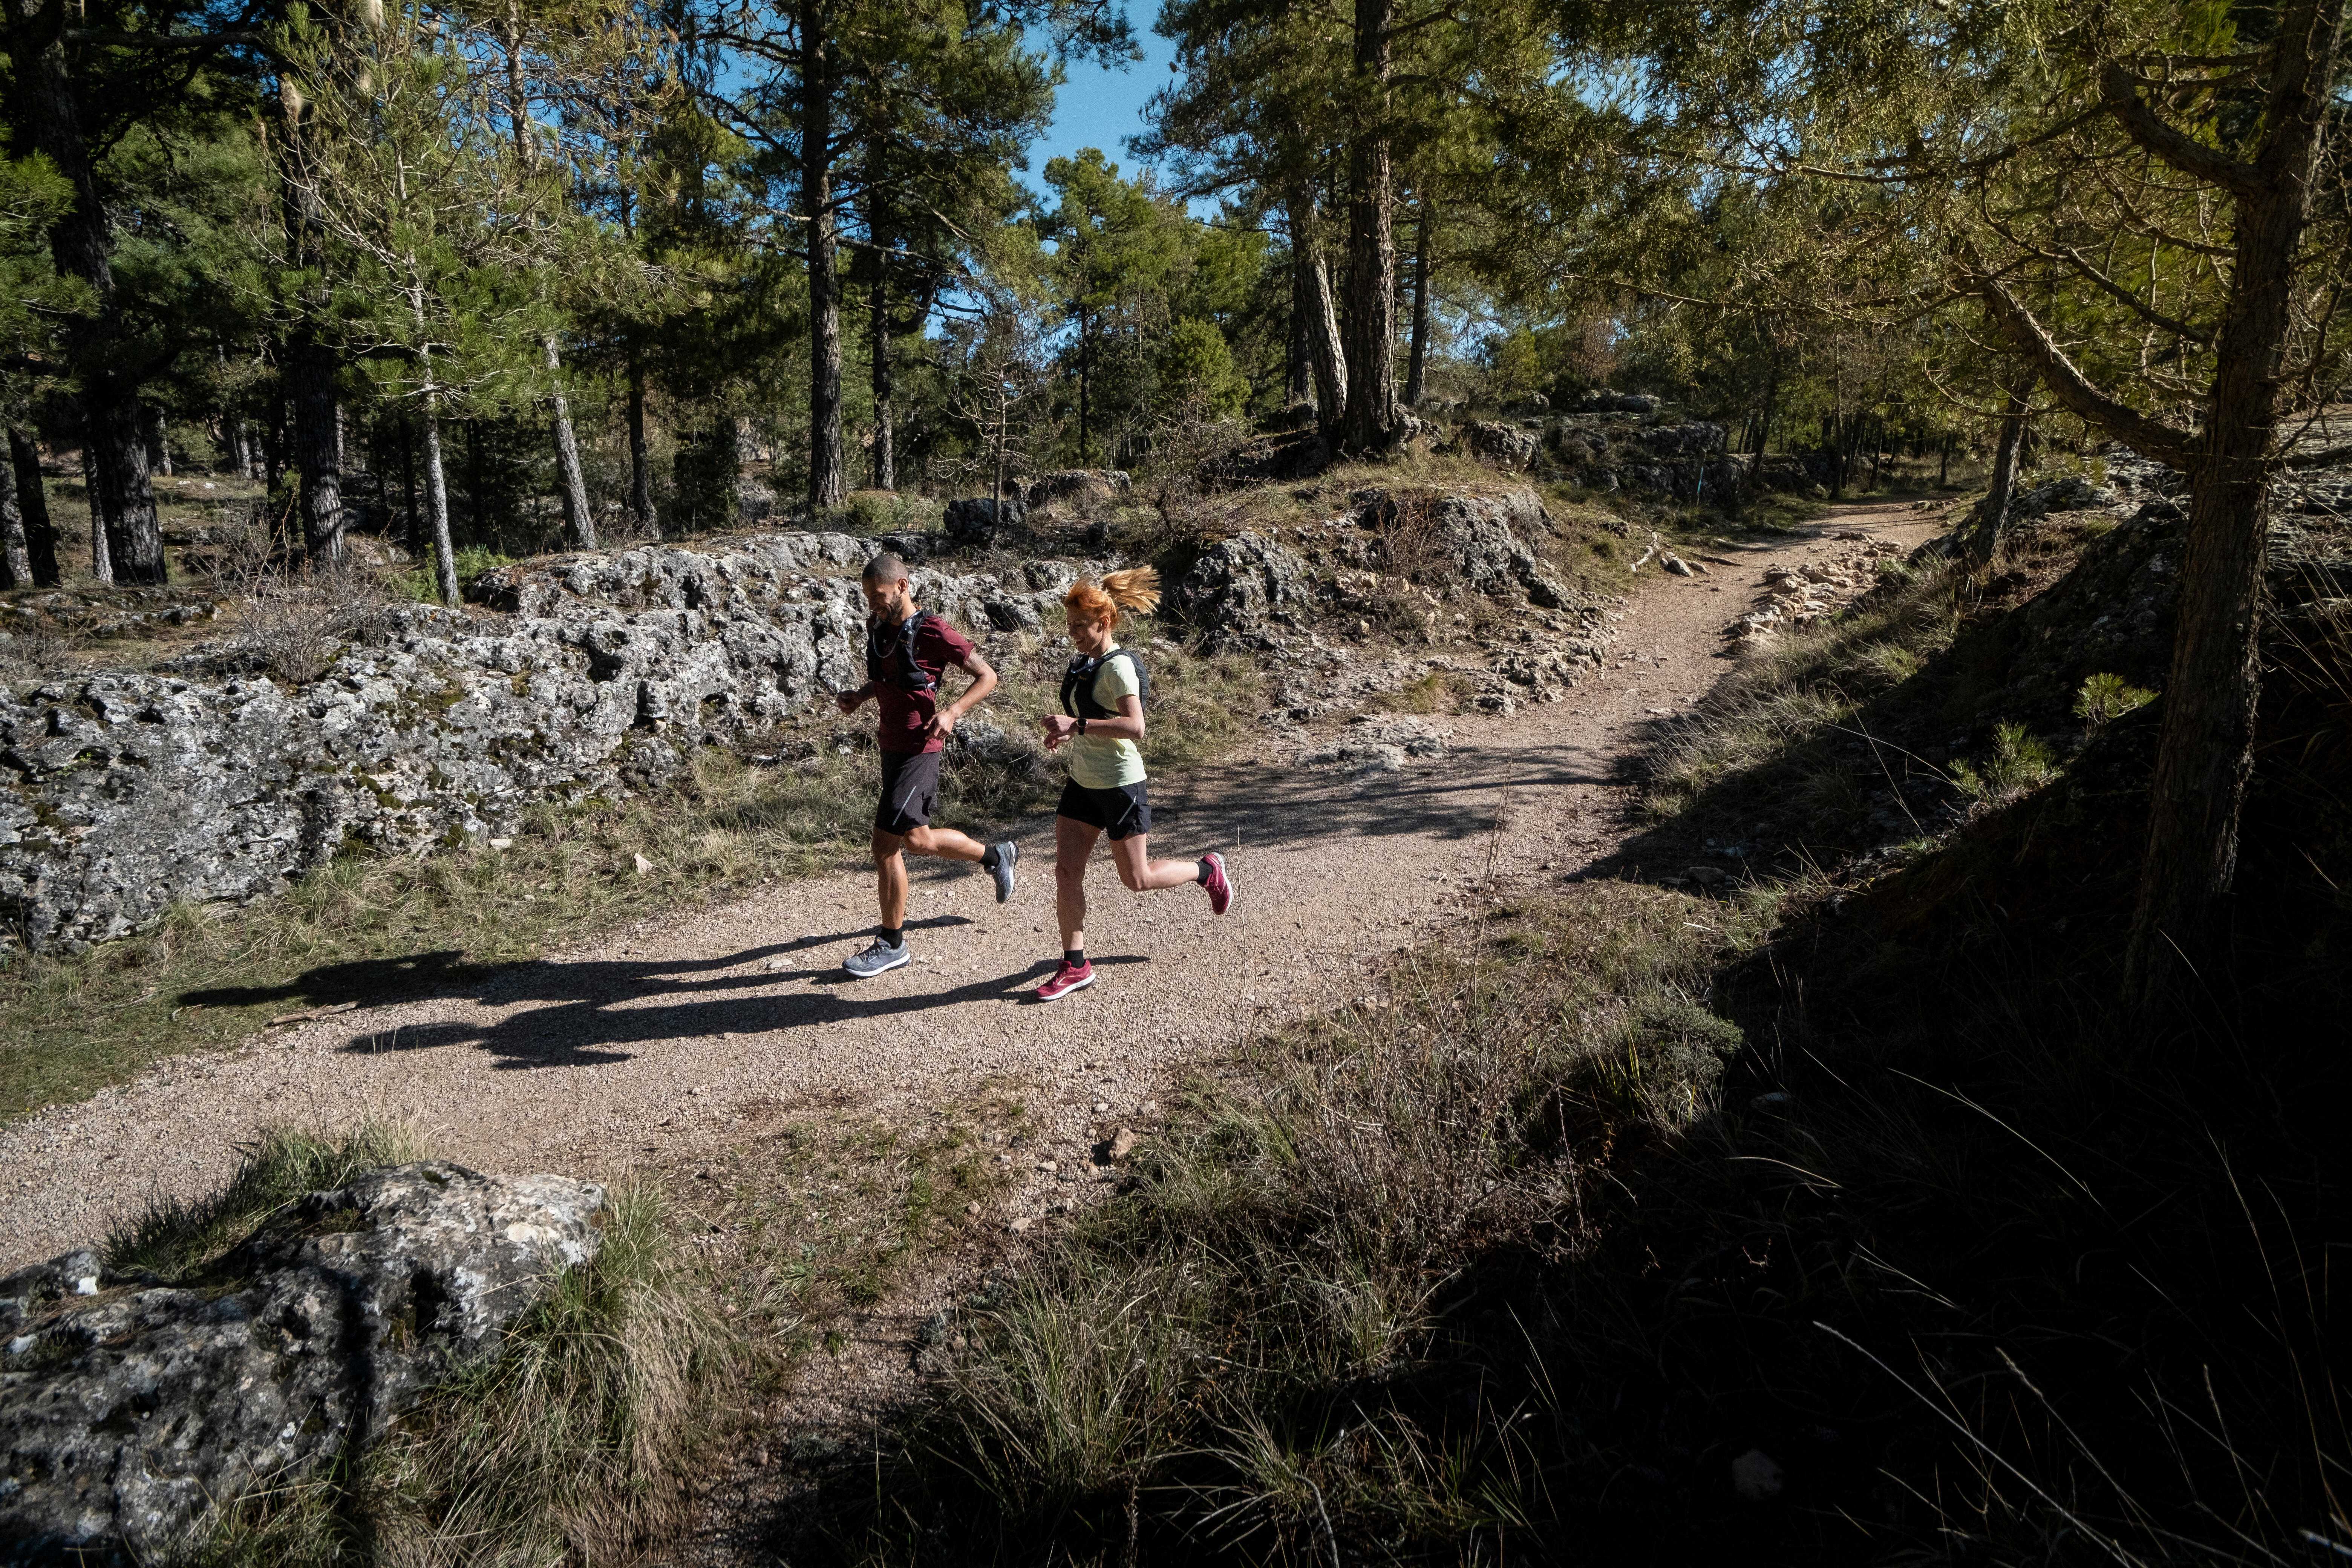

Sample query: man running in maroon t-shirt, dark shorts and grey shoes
[835,550,1021,980]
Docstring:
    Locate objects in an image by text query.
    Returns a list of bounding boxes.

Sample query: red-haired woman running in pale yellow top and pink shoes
[1037,567,1233,1001]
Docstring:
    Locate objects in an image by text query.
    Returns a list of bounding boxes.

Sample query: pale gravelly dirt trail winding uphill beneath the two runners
[0,505,1938,1272]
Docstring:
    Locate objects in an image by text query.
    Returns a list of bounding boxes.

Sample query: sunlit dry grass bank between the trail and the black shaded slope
[847,886,1769,1561]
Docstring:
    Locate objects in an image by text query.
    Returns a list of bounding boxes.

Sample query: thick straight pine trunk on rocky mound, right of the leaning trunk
[1341,0,1397,454]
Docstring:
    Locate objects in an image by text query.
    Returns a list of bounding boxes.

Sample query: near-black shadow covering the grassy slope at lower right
[724,515,2352,1566]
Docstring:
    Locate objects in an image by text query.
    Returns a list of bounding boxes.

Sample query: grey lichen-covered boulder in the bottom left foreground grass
[0,1161,605,1568]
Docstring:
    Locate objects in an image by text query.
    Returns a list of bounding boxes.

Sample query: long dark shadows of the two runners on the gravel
[341,931,1150,1070]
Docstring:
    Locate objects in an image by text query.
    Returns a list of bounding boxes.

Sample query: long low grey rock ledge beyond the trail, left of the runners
[0,534,1101,950]
